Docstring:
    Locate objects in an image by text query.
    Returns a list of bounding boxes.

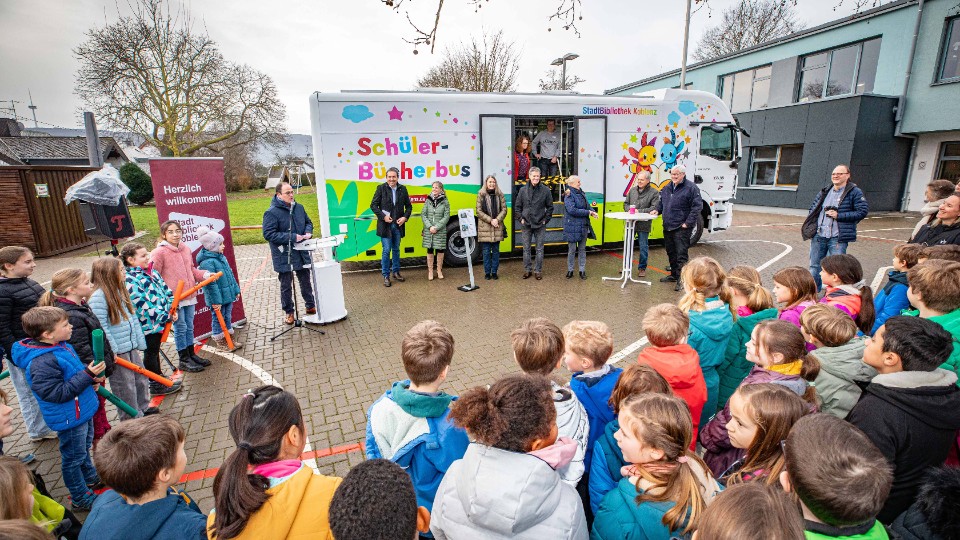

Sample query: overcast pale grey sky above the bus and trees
[0,0,852,133]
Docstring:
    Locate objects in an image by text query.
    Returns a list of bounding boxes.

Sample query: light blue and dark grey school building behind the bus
[606,0,960,210]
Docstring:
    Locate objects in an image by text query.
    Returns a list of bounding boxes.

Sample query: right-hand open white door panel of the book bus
[572,116,604,246]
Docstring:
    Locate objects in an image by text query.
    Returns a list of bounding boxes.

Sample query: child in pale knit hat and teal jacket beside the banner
[197,227,243,350]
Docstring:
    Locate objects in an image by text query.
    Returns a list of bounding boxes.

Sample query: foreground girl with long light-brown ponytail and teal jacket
[593,390,720,539]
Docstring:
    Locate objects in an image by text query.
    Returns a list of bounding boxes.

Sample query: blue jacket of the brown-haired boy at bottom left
[80,488,207,540]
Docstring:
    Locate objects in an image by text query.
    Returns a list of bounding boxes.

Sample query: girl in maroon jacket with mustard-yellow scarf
[700,320,820,476]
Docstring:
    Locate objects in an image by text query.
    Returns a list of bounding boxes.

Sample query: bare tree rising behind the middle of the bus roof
[417,30,520,92]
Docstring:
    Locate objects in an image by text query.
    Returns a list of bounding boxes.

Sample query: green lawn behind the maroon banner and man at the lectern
[130,187,319,246]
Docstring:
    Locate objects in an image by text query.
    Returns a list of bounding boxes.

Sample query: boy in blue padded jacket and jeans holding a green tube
[13,306,106,510]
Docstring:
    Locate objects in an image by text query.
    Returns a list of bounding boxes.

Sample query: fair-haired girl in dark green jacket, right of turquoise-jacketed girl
[705,266,777,417]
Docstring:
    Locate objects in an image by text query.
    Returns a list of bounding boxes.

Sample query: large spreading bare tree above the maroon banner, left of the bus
[73,0,286,156]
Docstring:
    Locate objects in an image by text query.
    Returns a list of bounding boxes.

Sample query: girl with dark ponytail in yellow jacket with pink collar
[207,386,340,540]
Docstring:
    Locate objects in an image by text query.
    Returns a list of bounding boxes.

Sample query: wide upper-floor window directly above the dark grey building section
[797,38,880,103]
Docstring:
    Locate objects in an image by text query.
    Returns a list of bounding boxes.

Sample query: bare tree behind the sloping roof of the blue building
[693,0,804,61]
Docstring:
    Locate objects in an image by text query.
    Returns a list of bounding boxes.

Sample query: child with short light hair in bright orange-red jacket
[637,304,707,445]
